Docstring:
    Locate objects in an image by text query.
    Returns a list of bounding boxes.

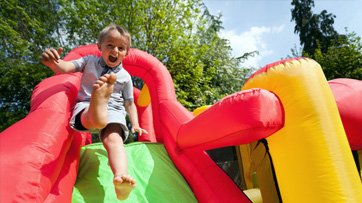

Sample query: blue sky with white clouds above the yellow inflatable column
[203,0,362,68]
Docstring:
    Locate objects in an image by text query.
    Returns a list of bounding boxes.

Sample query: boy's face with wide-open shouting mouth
[98,30,128,68]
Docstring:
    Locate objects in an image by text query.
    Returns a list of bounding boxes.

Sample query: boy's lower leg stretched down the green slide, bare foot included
[102,123,136,200]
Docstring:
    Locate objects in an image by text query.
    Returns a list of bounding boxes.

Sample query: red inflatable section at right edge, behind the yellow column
[328,78,362,150]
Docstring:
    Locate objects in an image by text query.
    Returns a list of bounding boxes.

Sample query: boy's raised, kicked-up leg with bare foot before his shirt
[81,73,116,130]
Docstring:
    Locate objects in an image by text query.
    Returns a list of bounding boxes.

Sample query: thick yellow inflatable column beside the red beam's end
[243,58,362,203]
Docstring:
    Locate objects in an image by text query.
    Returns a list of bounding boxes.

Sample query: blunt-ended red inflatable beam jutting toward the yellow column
[177,89,284,149]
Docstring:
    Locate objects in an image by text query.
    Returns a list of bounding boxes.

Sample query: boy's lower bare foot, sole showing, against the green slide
[113,175,136,200]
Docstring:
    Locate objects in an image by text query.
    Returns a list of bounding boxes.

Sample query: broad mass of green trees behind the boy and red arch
[0,0,249,130]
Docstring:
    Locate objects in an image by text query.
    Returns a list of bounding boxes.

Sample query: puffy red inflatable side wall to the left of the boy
[0,75,87,202]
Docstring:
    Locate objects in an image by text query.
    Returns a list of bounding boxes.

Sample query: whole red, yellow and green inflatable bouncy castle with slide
[0,45,362,203]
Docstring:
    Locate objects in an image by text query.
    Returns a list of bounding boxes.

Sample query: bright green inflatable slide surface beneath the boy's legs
[72,142,197,203]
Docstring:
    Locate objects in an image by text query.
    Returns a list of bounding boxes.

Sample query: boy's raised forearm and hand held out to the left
[40,48,76,74]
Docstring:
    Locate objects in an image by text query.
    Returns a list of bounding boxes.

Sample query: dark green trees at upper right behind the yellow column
[292,0,362,80]
